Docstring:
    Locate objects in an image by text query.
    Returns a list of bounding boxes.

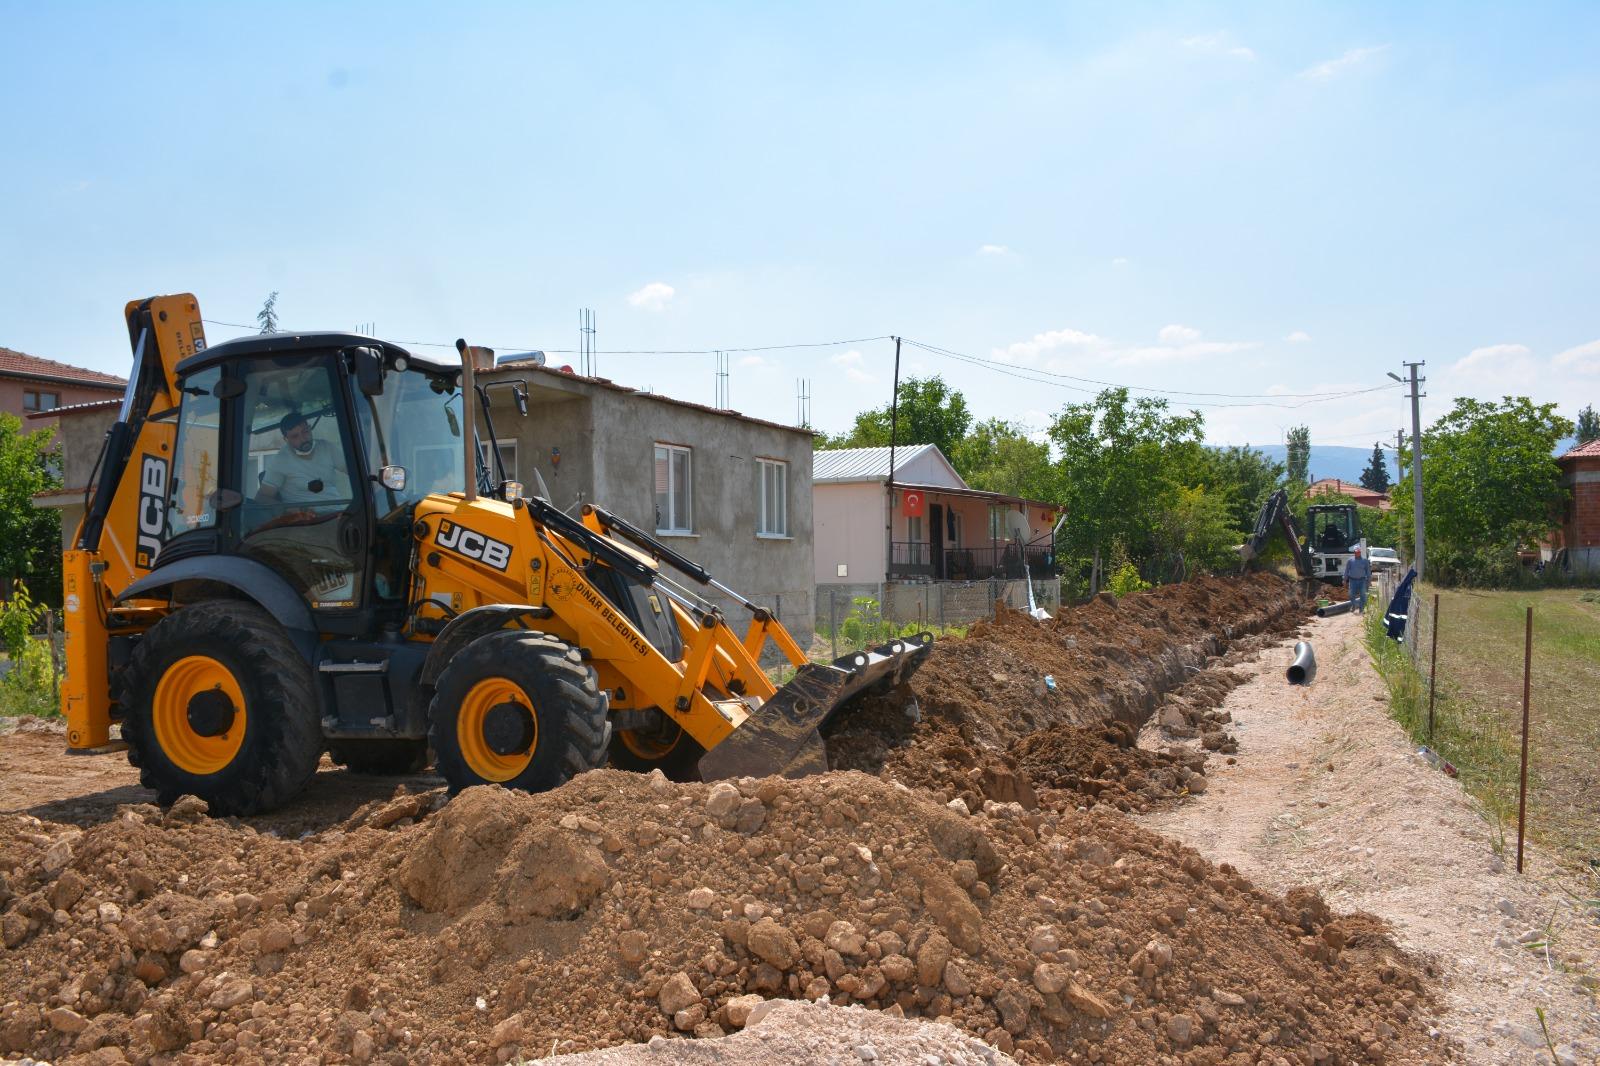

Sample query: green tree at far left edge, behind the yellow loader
[0,415,61,603]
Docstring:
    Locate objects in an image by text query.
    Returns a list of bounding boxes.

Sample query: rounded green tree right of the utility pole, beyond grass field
[1390,397,1573,584]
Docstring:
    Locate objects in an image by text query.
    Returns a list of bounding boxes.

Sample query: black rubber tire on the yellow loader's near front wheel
[427,629,611,795]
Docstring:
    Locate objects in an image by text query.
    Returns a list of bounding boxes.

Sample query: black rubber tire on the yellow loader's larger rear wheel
[117,600,322,816]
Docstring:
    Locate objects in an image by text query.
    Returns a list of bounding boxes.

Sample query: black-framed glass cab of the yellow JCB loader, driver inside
[157,333,464,637]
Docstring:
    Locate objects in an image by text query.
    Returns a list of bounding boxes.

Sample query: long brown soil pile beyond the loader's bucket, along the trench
[829,573,1309,810]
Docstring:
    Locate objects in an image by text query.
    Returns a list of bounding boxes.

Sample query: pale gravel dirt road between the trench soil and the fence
[1141,615,1600,1063]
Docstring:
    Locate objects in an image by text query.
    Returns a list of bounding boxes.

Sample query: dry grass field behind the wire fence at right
[1384,589,1600,868]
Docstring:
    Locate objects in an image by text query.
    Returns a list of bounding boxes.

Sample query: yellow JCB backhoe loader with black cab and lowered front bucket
[62,295,931,815]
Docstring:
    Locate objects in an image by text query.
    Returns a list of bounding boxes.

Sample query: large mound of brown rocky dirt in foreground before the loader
[0,770,1427,1064]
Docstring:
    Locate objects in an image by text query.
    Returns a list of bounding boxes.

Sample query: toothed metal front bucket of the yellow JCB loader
[699,632,933,781]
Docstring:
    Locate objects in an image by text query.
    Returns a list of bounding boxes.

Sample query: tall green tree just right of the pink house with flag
[1050,389,1205,585]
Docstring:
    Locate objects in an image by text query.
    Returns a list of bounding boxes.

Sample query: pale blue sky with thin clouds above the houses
[0,0,1600,445]
